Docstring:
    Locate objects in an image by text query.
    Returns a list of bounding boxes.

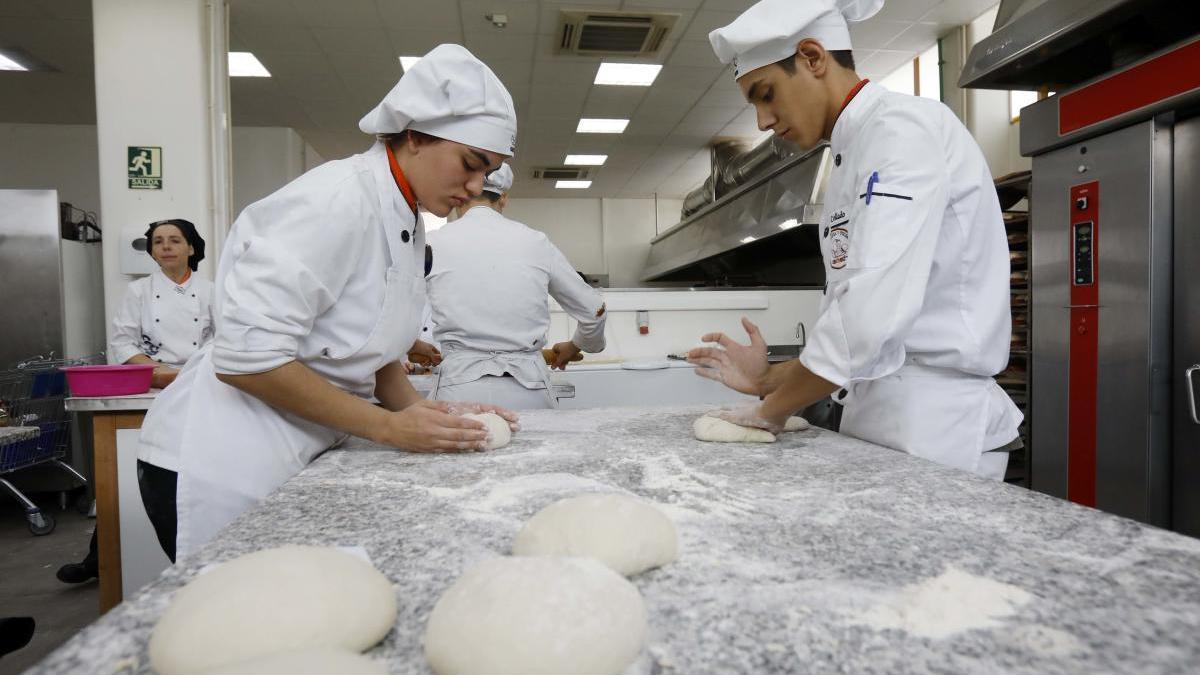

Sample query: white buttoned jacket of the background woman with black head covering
[108,269,212,368]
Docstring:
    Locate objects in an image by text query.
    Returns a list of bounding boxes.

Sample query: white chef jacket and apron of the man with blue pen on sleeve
[800,83,1021,471]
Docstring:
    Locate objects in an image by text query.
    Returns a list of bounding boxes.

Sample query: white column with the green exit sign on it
[92,0,230,341]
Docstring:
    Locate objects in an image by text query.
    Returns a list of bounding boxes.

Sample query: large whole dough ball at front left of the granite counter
[150,546,396,675]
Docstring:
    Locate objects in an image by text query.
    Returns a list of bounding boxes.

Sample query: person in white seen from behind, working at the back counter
[428,159,607,410]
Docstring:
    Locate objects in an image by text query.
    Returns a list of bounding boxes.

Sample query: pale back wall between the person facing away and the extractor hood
[504,198,683,283]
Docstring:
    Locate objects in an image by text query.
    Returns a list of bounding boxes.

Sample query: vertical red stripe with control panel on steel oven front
[1064,181,1100,507]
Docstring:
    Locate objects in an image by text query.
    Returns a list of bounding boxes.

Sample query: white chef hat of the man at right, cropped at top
[708,0,883,79]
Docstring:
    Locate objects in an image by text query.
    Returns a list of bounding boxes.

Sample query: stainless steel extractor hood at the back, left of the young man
[642,144,829,287]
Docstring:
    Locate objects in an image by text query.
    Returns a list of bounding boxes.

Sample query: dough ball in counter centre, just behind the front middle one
[512,487,679,575]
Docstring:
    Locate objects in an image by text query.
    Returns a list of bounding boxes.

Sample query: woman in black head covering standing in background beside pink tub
[108,219,212,389]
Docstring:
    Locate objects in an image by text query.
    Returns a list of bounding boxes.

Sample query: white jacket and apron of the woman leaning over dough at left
[138,143,425,555]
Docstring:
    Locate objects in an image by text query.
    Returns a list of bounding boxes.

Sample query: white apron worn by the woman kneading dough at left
[173,218,425,556]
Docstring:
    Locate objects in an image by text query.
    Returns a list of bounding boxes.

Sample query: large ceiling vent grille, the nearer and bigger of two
[558,12,679,56]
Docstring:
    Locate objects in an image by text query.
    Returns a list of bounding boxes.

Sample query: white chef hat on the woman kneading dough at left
[359,44,517,156]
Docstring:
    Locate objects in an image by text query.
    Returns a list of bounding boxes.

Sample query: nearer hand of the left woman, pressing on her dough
[372,400,489,453]
